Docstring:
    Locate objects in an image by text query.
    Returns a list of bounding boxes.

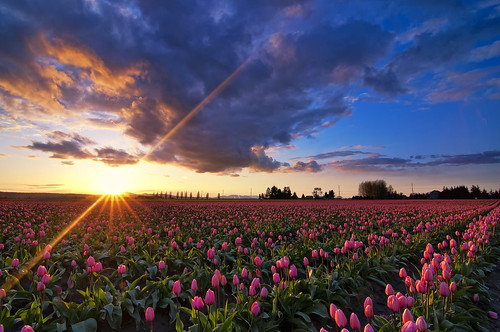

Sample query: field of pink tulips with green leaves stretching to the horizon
[0,196,500,332]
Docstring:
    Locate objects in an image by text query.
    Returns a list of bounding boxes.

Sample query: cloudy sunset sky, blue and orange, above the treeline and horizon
[0,0,500,197]
